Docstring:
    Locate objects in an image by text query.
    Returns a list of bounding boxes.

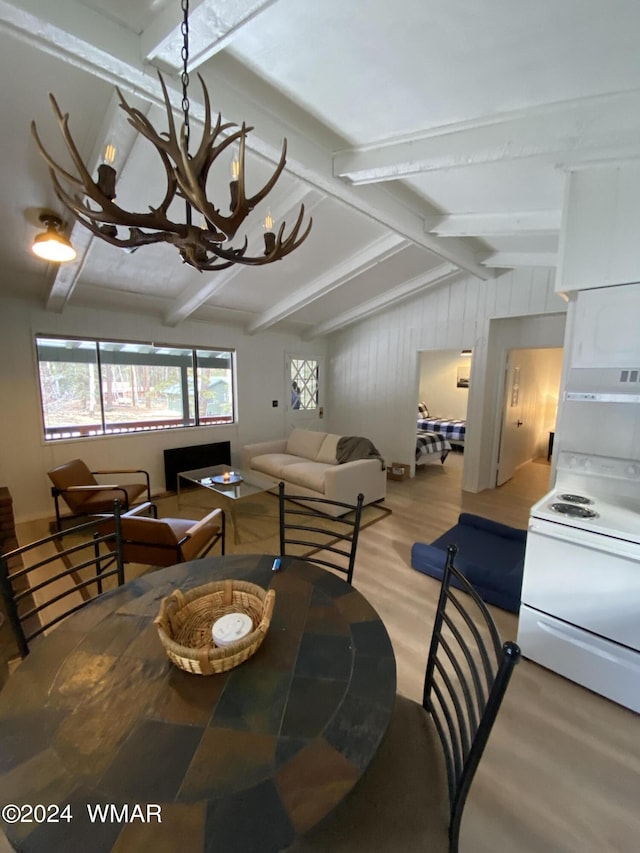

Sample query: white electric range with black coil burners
[518,451,640,712]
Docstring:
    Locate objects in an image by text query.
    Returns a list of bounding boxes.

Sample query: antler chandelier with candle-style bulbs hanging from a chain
[31,0,312,271]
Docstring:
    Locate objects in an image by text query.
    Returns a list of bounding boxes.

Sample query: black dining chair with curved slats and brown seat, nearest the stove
[289,545,520,853]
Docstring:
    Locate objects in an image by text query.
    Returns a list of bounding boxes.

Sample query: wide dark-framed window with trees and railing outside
[36,337,235,440]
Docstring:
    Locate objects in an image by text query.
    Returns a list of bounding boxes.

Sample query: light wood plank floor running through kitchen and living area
[7,460,640,853]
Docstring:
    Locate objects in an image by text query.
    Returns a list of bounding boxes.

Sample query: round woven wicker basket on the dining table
[155,580,276,675]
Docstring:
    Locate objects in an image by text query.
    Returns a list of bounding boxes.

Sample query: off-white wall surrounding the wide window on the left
[0,299,326,521]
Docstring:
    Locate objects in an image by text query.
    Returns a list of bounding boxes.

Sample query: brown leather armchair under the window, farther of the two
[48,459,158,530]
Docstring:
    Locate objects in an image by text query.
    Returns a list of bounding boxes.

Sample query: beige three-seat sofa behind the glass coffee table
[242,429,387,516]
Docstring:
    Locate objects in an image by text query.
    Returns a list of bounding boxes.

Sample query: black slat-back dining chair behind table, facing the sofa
[278,483,364,583]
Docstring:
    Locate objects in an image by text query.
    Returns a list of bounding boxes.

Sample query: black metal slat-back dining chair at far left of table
[0,501,124,657]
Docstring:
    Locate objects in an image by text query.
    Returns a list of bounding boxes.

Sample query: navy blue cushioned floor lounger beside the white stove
[411,512,527,613]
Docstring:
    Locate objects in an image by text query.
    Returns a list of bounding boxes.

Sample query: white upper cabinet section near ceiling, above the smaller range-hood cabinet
[555,162,640,294]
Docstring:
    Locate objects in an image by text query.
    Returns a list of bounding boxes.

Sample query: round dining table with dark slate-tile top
[0,554,396,853]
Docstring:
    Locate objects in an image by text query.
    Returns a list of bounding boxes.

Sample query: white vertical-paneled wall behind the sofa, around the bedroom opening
[327,269,566,491]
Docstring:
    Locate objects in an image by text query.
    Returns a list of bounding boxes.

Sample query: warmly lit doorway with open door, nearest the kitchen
[495,347,563,486]
